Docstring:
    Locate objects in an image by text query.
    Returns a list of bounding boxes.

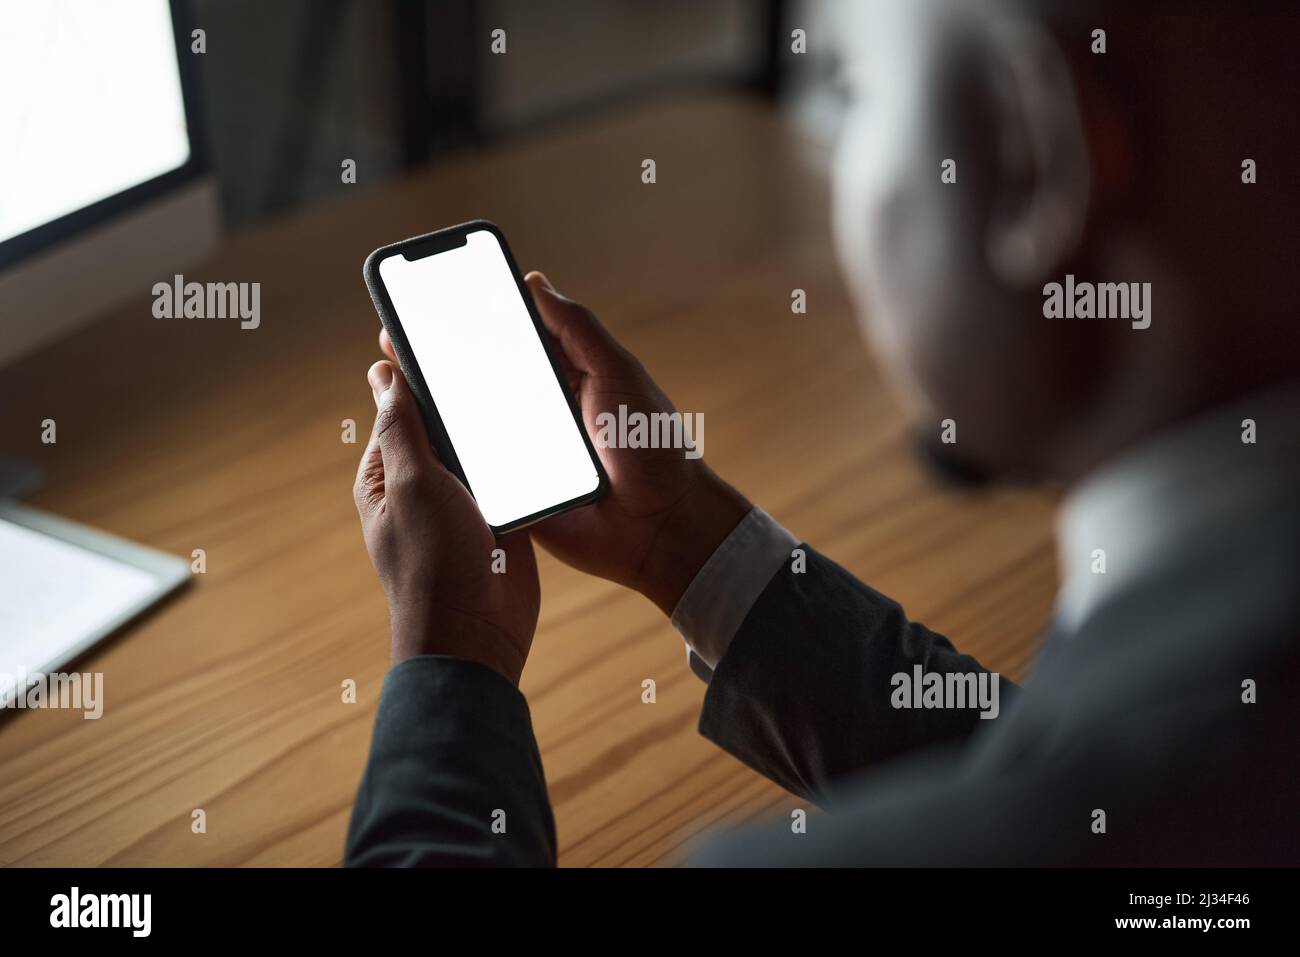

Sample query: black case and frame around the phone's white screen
[361,220,610,536]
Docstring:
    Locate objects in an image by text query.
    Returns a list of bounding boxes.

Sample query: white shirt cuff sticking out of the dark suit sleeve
[672,507,800,680]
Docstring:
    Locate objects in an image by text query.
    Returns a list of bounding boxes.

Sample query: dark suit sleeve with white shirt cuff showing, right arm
[699,545,1015,801]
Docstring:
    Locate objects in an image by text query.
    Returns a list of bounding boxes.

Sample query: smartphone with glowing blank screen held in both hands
[363,220,608,534]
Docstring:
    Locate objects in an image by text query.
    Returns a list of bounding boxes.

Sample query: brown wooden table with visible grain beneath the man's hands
[0,96,1056,865]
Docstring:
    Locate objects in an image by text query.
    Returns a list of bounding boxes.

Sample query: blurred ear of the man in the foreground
[987,20,1089,287]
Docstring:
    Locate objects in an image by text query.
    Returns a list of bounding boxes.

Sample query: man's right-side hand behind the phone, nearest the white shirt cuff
[380,272,750,615]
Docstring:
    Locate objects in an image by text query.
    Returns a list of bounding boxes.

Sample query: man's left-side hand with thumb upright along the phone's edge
[354,361,540,685]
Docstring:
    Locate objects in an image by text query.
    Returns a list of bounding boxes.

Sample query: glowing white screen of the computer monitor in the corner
[0,0,191,244]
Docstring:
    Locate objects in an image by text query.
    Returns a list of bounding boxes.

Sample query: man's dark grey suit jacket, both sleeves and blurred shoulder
[346,505,1300,865]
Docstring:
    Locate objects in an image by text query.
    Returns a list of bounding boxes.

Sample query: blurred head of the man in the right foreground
[835,0,1300,481]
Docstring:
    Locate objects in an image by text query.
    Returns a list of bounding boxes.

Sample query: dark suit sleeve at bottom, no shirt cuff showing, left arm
[345,655,555,866]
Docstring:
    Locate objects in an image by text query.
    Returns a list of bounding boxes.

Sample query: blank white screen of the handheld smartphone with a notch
[380,230,599,527]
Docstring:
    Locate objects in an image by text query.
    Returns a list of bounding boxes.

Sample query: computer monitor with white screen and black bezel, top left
[0,0,218,365]
